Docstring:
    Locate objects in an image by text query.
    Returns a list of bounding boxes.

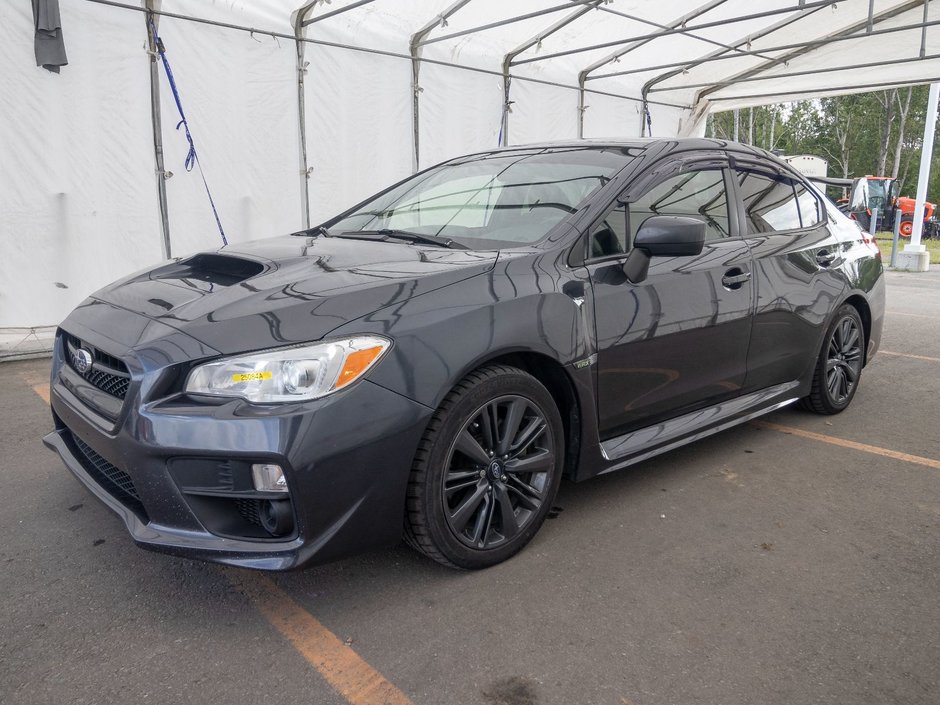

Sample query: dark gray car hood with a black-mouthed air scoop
[92,235,499,354]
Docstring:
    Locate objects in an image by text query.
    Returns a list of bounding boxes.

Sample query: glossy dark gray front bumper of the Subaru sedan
[44,332,431,570]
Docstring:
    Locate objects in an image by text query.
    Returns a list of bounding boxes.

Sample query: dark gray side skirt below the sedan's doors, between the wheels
[599,381,800,475]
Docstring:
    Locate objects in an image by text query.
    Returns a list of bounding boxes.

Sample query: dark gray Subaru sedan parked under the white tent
[45,140,884,569]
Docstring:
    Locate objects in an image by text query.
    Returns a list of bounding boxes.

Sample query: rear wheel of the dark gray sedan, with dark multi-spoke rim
[801,304,865,414]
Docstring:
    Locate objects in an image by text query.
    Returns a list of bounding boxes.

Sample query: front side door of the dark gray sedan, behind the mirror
[586,156,753,438]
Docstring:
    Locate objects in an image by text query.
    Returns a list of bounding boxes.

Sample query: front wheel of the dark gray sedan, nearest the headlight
[404,365,565,569]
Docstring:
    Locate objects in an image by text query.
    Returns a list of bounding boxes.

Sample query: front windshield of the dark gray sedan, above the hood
[329,148,632,247]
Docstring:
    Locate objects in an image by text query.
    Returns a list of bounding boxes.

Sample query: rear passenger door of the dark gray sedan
[734,163,846,391]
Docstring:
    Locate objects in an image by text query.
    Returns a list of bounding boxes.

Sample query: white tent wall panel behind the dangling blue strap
[154,15,301,256]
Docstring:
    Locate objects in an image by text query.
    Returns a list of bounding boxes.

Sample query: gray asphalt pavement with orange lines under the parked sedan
[0,271,940,705]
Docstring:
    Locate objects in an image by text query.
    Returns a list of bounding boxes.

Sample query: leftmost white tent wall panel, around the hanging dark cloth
[0,2,161,352]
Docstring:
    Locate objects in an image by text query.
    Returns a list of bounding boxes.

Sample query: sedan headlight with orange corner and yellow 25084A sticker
[186,335,391,402]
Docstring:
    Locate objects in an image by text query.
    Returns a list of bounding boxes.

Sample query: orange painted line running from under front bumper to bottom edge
[223,568,412,705]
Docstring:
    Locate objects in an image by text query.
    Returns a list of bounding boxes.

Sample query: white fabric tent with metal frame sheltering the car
[0,0,940,355]
